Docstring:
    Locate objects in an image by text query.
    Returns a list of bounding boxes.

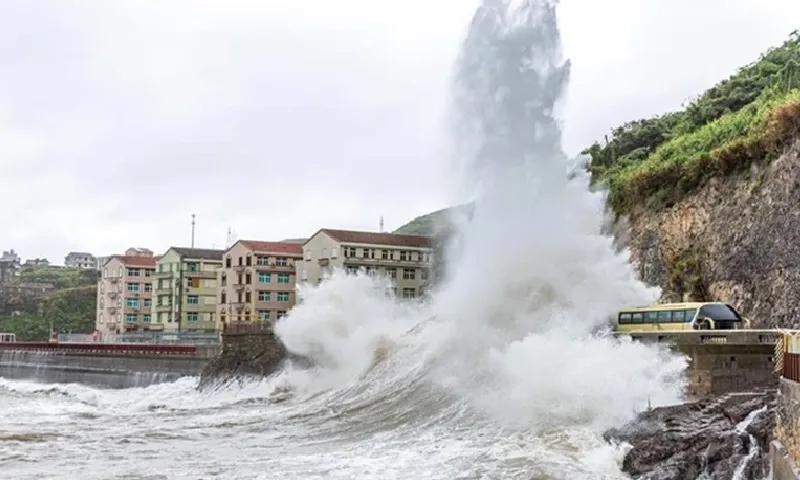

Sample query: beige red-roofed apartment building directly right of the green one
[217,240,303,328]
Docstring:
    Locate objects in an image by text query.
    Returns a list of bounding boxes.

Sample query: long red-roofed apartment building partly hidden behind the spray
[298,228,434,298]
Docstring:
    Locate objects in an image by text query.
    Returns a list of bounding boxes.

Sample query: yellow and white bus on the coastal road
[614,302,750,332]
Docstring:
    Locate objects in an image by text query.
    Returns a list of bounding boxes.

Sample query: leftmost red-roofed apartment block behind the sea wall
[96,255,156,337]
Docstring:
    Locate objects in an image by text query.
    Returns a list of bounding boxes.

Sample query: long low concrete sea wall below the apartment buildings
[0,343,218,388]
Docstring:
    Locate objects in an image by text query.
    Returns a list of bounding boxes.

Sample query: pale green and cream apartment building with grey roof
[153,247,225,331]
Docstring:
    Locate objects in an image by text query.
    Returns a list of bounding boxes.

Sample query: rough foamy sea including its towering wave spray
[0,0,686,480]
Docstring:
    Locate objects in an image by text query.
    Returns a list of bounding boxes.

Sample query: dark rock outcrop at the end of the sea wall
[198,332,305,389]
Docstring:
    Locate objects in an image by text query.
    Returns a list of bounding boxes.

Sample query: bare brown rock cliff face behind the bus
[630,142,800,328]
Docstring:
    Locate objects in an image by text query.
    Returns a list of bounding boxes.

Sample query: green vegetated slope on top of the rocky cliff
[584,32,800,212]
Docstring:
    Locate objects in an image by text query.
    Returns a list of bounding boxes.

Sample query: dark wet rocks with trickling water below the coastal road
[606,390,775,480]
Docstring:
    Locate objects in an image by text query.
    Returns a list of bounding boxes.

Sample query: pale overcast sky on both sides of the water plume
[0,0,800,263]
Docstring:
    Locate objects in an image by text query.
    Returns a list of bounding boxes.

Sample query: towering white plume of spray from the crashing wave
[278,0,685,436]
